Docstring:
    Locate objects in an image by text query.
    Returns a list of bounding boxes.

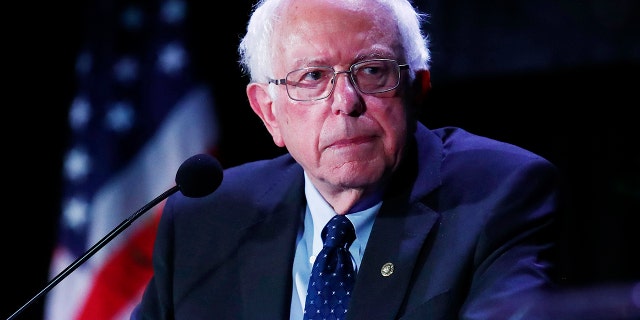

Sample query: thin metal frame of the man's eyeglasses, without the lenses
[268,58,409,101]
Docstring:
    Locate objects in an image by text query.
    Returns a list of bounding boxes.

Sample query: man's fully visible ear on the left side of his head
[246,83,284,147]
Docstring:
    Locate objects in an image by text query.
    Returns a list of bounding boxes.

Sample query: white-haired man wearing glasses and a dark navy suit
[132,0,560,320]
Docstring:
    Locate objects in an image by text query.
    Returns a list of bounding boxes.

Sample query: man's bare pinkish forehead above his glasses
[274,0,399,66]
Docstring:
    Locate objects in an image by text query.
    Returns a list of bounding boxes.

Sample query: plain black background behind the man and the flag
[5,0,640,319]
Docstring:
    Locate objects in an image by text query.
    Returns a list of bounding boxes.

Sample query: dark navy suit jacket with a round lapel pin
[133,124,559,320]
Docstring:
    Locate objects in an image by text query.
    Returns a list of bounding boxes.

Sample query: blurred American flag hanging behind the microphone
[44,0,218,320]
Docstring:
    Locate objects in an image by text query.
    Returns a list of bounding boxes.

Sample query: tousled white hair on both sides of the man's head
[238,0,431,82]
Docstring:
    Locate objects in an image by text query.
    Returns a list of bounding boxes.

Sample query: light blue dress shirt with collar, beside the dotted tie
[290,173,382,320]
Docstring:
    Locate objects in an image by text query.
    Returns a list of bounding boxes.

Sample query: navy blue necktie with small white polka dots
[304,215,356,320]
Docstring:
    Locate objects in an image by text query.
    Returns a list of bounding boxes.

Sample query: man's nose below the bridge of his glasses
[331,70,364,117]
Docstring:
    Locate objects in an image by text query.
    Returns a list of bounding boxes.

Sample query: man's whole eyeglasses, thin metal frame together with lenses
[269,59,409,101]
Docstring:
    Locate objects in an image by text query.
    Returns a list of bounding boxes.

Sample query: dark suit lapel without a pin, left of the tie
[238,169,305,319]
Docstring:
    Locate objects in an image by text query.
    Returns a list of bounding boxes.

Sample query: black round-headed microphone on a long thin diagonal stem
[7,153,223,320]
